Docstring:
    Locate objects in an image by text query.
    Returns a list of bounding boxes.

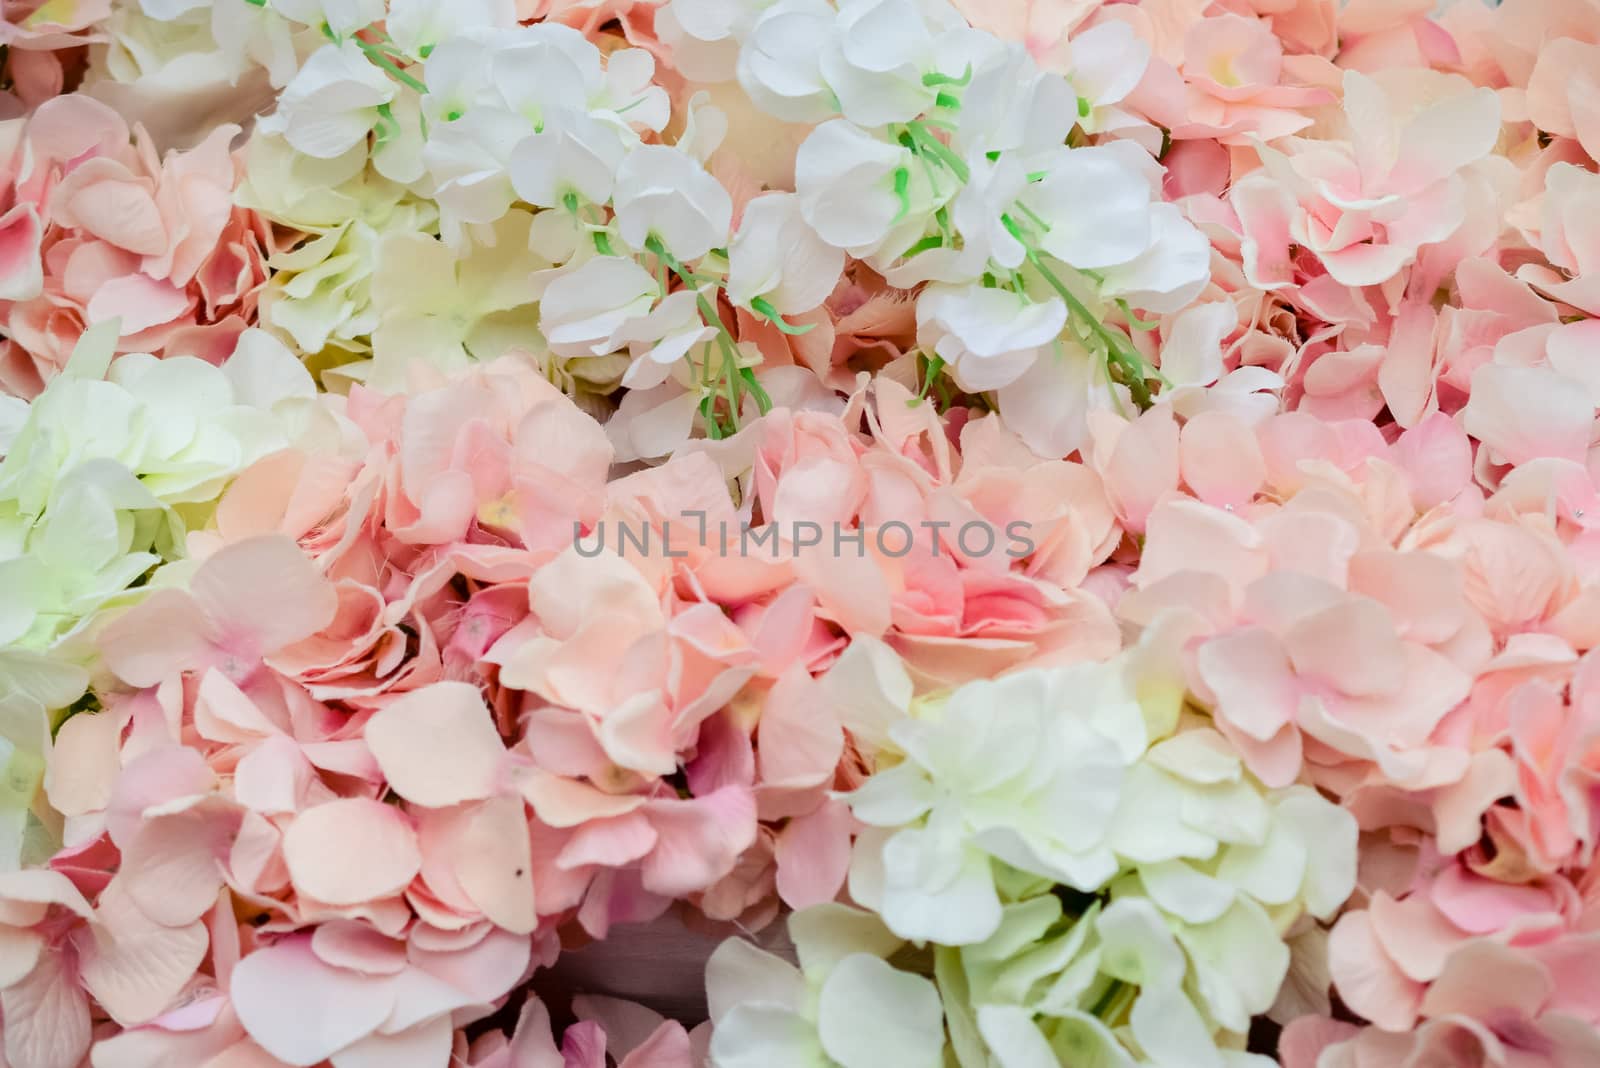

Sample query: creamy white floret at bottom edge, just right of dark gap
[706,905,944,1068]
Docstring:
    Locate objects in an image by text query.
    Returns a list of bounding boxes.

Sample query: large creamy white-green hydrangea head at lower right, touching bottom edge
[793,640,1357,1068]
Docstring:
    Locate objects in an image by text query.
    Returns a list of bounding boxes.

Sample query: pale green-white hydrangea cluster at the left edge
[0,323,322,708]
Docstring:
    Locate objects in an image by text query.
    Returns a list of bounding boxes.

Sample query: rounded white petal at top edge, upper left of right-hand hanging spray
[739,0,838,123]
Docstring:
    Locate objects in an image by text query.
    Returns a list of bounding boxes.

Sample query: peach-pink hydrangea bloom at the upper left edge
[0,94,272,397]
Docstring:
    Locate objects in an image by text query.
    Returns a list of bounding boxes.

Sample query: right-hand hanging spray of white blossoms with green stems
[681,0,1210,456]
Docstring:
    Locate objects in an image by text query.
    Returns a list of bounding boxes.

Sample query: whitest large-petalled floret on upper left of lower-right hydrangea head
[850,665,1142,945]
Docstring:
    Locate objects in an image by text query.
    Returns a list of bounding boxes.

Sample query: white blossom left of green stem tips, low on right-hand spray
[917,285,1067,392]
